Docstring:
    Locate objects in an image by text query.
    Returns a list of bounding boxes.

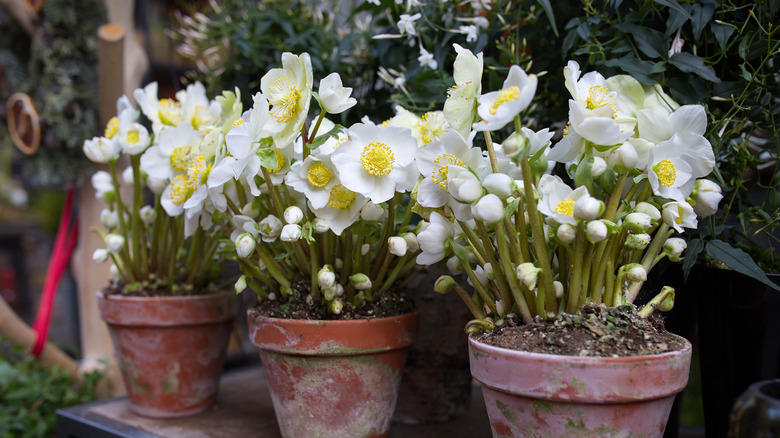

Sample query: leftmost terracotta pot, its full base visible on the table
[98,293,235,418]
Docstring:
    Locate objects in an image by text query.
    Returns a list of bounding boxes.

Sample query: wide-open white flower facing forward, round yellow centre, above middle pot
[331,123,417,204]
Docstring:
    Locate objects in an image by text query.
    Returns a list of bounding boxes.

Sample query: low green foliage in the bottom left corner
[0,342,100,438]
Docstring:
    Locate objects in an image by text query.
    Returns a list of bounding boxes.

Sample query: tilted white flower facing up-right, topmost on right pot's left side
[474,65,537,131]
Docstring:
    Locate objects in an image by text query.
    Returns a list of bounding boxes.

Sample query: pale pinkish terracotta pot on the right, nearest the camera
[469,338,691,437]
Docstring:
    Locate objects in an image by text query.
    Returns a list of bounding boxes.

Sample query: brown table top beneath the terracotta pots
[57,367,491,438]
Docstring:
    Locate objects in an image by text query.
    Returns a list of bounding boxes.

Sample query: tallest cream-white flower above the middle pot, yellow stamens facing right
[260,52,314,148]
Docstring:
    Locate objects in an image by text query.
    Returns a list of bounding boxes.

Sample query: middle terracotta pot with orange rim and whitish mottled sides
[248,309,418,438]
